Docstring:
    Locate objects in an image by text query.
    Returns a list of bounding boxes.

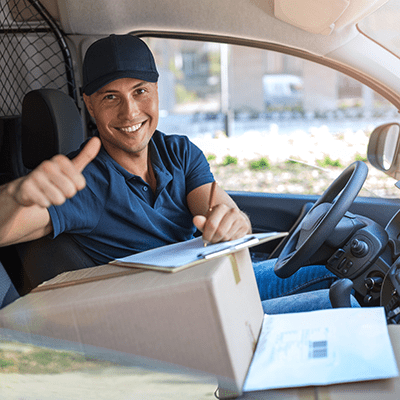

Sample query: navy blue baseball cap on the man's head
[82,35,158,96]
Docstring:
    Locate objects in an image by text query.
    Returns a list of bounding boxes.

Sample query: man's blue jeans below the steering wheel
[253,259,359,314]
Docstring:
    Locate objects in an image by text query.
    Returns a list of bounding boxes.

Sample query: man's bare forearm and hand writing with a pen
[187,183,251,243]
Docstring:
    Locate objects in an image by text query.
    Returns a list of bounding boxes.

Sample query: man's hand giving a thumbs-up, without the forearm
[7,137,101,208]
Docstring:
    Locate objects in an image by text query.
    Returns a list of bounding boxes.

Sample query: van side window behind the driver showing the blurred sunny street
[147,38,399,197]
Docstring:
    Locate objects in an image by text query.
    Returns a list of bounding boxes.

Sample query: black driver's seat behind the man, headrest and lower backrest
[15,89,95,294]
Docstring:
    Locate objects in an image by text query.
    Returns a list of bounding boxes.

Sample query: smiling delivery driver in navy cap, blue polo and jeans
[0,35,344,311]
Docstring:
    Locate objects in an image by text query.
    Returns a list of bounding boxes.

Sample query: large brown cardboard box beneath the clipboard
[0,249,264,393]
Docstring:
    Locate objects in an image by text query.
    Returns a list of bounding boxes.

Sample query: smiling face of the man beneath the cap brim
[83,78,158,162]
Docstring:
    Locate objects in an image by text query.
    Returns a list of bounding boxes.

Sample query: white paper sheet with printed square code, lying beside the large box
[243,307,398,392]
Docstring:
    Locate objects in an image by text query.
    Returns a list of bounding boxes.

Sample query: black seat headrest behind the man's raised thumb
[21,89,85,169]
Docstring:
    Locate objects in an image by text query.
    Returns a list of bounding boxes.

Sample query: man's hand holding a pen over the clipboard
[193,204,251,243]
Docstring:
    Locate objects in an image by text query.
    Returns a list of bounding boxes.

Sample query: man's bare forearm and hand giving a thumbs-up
[0,138,100,246]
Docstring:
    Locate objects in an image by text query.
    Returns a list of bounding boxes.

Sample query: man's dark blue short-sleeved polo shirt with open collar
[48,131,214,264]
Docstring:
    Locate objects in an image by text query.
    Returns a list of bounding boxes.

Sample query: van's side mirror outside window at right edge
[367,123,400,180]
